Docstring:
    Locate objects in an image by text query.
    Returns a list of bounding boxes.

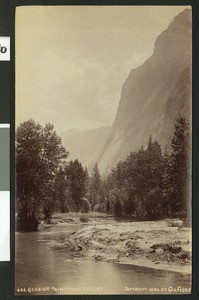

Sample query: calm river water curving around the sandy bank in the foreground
[15,225,190,295]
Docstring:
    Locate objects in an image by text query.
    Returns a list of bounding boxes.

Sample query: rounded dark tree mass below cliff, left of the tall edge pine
[113,137,164,218]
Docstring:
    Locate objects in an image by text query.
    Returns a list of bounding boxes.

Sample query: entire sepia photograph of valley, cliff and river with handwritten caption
[15,5,192,296]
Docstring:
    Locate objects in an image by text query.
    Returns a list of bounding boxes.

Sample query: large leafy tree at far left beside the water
[16,119,68,230]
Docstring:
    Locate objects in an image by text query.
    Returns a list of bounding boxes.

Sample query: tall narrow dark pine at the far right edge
[169,115,191,218]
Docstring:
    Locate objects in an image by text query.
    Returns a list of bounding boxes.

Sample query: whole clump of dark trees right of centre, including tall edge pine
[104,116,191,219]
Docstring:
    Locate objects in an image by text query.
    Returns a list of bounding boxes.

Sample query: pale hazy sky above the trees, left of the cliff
[15,6,187,133]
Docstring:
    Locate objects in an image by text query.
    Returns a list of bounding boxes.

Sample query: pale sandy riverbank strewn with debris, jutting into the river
[63,216,192,274]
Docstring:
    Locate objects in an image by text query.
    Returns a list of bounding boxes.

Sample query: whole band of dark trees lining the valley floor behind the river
[16,115,191,231]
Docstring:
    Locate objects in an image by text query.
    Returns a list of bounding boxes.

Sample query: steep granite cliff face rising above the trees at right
[97,9,192,175]
